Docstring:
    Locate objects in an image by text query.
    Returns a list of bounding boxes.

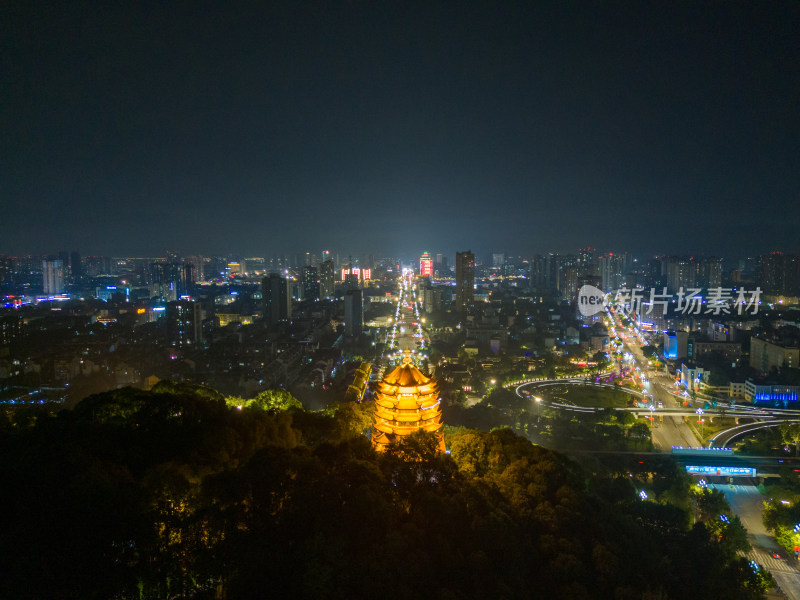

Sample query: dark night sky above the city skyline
[0,0,800,256]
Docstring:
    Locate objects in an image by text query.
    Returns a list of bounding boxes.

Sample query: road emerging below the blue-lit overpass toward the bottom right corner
[708,484,800,600]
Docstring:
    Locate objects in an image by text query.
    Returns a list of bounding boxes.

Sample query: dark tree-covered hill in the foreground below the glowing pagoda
[0,384,764,600]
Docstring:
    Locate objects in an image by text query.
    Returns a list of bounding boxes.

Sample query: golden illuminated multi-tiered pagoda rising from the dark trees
[372,350,445,452]
